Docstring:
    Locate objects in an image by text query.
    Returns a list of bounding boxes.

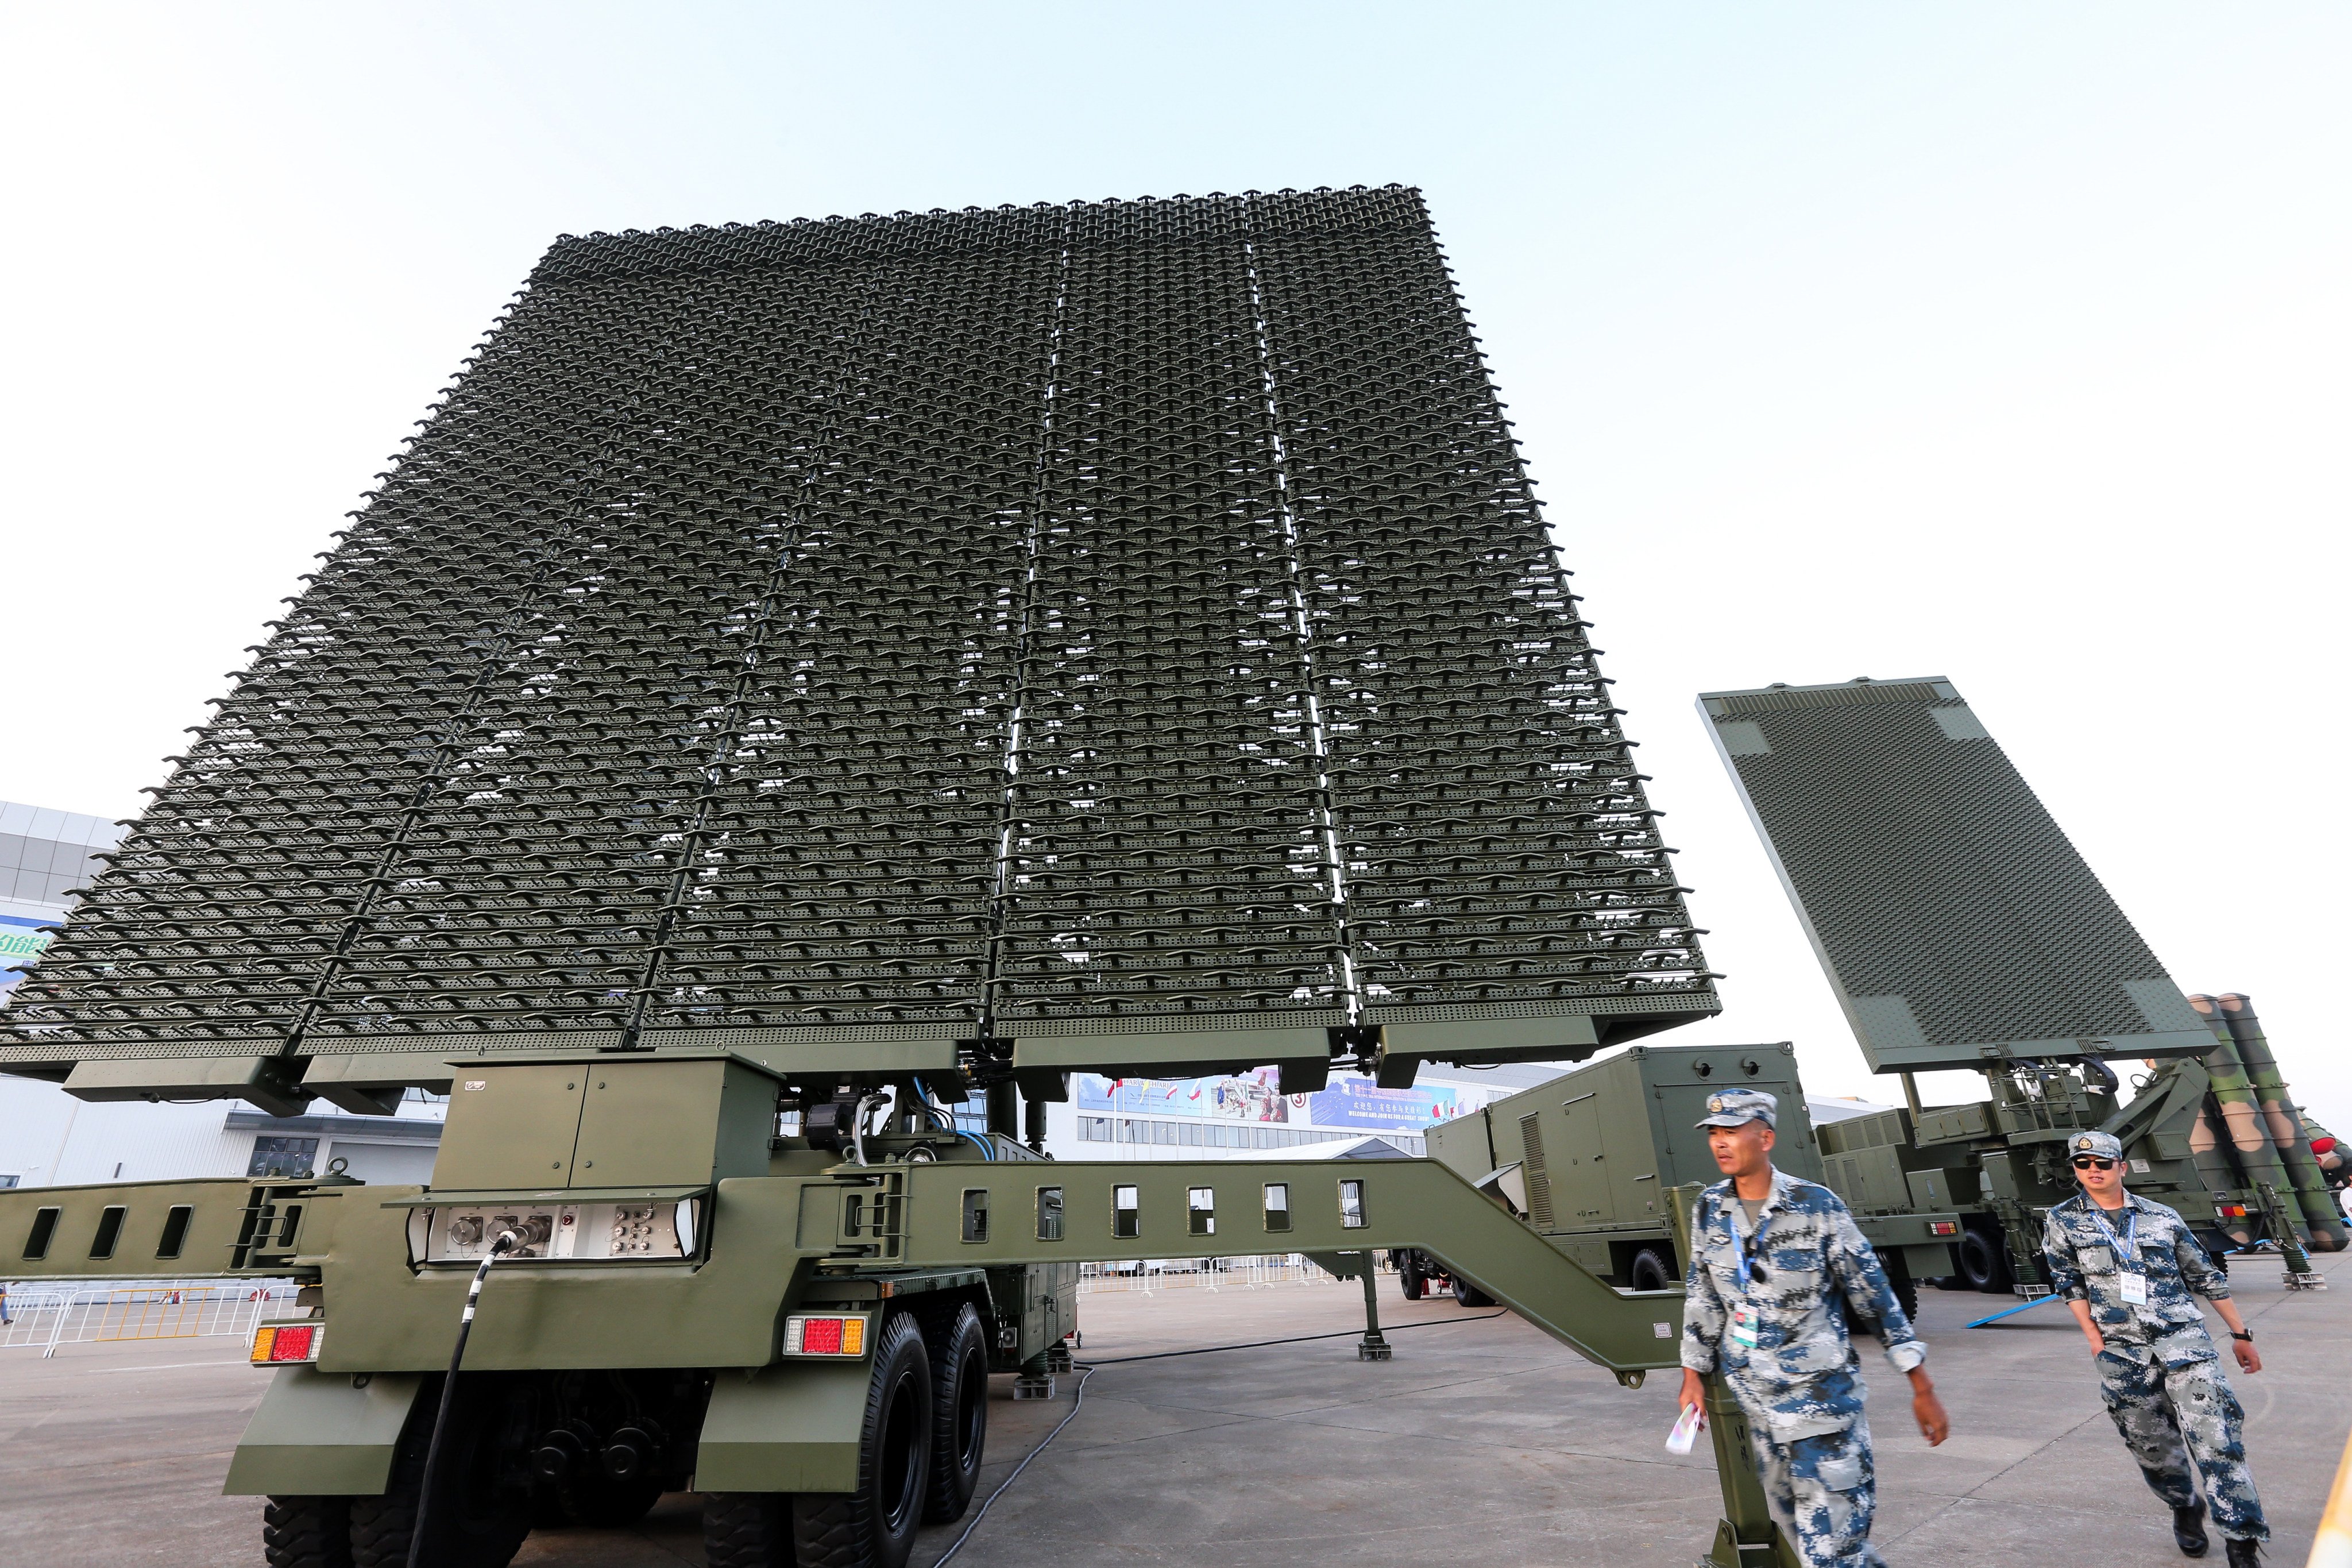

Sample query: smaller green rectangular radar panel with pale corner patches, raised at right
[1698,677,2213,1072]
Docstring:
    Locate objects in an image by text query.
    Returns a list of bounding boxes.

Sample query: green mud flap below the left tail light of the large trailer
[221,1366,423,1497]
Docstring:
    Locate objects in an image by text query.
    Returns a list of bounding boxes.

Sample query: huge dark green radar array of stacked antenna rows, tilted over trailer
[0,188,1717,1105]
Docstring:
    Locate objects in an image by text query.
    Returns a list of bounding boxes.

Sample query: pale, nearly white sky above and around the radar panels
[0,2,2352,1114]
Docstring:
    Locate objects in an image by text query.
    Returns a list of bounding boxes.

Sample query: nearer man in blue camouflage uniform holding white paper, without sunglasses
[1682,1088,1950,1566]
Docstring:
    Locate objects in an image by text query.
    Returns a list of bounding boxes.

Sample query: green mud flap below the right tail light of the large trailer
[694,1359,872,1493]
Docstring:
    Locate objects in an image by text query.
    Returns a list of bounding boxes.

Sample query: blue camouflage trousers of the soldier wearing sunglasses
[2098,1349,2270,1540]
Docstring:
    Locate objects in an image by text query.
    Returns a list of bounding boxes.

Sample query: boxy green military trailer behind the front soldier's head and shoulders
[1397,1041,1959,1310]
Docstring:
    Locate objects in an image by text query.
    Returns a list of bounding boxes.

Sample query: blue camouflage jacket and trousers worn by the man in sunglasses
[2041,1192,2270,1540]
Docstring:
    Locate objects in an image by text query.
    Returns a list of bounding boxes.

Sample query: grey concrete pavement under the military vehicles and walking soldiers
[0,1258,2352,1568]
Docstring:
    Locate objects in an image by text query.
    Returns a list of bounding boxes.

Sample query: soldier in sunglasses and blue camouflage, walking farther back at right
[2041,1133,2270,1563]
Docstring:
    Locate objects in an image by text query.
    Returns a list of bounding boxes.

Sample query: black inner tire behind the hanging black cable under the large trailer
[350,1375,531,1568]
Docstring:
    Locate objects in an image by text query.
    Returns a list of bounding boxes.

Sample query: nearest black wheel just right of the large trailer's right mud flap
[793,1312,932,1568]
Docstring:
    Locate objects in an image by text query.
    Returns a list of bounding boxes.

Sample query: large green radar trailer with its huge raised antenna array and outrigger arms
[0,188,1816,1568]
